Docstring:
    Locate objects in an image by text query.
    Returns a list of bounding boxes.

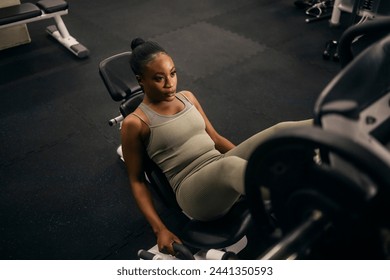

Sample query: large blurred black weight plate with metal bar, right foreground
[246,127,390,259]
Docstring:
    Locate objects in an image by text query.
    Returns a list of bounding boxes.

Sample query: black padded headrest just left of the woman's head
[99,52,141,101]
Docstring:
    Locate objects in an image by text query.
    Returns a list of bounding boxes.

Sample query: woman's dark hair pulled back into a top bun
[130,38,167,75]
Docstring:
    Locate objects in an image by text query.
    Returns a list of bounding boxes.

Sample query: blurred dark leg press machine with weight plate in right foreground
[245,32,390,259]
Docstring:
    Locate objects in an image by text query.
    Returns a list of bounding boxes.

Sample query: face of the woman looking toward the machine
[139,53,177,102]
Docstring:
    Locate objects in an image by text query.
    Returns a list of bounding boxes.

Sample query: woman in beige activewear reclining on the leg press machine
[121,38,311,254]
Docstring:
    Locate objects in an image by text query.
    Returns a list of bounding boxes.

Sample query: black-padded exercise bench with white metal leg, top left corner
[0,0,89,58]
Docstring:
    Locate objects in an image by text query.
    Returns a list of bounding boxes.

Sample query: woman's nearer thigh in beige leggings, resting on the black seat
[176,157,247,220]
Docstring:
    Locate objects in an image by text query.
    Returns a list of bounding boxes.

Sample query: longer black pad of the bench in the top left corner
[0,3,42,25]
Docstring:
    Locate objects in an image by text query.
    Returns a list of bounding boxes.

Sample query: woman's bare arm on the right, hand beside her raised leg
[184,91,235,154]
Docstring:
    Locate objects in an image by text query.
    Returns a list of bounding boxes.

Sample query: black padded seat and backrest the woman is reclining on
[99,52,272,259]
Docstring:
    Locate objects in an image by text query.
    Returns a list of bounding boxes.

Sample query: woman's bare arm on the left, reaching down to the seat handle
[121,115,181,255]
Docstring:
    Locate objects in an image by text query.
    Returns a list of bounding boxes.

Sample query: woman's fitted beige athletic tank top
[136,93,221,191]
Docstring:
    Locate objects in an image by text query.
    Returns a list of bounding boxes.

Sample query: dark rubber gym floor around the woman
[0,0,344,260]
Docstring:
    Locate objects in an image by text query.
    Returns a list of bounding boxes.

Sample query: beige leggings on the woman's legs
[176,119,313,221]
